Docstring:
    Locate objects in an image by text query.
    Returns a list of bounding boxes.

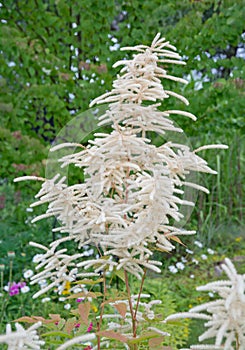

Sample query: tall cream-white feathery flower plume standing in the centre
[14,34,225,285]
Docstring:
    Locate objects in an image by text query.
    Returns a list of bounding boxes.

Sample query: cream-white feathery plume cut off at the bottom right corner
[166,258,245,350]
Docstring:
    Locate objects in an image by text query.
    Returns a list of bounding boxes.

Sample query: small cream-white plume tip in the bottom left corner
[0,322,45,350]
